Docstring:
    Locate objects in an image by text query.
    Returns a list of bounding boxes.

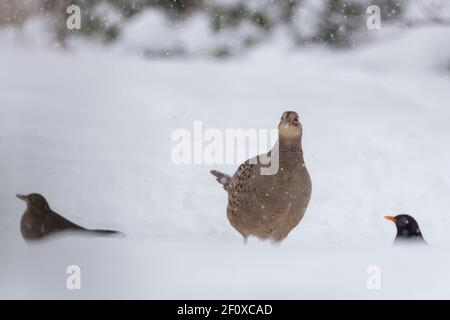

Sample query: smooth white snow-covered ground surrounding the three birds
[0,28,450,299]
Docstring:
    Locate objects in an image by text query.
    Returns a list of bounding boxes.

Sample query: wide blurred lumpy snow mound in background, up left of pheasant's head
[114,9,263,56]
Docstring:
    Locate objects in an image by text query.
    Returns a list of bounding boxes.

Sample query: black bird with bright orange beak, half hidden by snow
[385,214,427,245]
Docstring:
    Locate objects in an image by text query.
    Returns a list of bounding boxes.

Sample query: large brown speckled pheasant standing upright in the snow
[211,111,311,242]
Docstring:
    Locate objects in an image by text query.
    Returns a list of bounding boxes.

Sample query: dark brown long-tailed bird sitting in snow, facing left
[16,193,121,240]
